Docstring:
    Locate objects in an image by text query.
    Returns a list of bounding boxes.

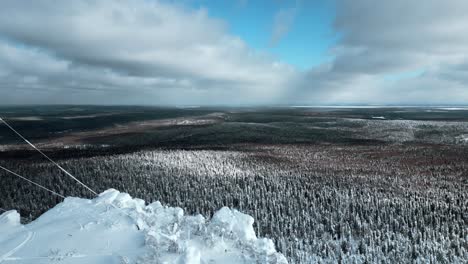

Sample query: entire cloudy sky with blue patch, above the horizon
[0,0,468,105]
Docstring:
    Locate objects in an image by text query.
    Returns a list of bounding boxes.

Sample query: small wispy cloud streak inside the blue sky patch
[270,7,297,46]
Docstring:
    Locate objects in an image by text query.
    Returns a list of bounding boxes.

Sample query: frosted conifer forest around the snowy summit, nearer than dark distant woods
[0,144,468,263]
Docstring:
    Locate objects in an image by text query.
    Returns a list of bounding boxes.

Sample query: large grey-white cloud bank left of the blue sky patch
[0,0,293,103]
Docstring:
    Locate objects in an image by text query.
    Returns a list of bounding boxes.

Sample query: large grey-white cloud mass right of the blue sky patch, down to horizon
[293,0,468,104]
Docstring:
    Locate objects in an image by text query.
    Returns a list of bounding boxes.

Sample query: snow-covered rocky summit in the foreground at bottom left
[0,189,287,264]
